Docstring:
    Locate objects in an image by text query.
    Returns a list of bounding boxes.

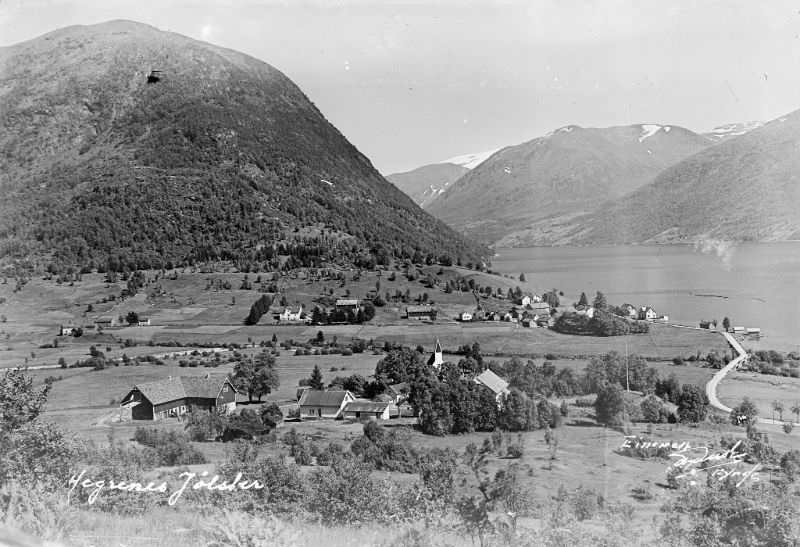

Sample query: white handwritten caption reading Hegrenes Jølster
[67,469,264,505]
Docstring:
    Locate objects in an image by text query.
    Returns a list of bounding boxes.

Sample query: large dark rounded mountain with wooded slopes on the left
[0,21,488,270]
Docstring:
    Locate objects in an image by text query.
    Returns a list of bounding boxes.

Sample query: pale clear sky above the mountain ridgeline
[0,0,800,174]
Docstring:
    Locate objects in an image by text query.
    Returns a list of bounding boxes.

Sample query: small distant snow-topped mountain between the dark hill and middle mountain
[386,150,497,209]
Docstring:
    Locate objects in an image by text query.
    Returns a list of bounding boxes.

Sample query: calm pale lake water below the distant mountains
[492,242,800,351]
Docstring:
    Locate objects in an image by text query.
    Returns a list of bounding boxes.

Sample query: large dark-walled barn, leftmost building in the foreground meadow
[120,375,237,420]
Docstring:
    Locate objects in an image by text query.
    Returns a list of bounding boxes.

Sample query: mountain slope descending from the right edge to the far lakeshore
[554,110,800,244]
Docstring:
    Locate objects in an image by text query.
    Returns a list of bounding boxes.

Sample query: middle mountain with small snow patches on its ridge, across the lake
[427,124,712,246]
